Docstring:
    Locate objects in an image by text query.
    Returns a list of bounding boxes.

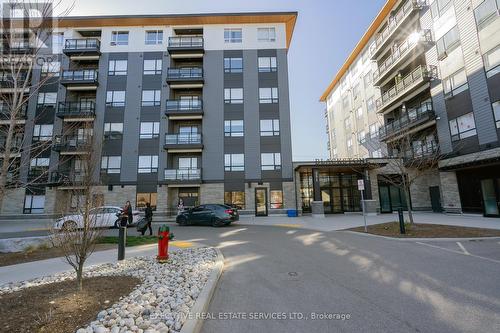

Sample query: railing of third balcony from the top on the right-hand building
[376,66,437,112]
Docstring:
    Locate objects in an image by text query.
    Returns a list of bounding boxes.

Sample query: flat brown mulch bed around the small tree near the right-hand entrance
[347,222,500,238]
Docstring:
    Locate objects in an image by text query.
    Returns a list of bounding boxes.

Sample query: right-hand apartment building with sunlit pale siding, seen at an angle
[321,0,500,216]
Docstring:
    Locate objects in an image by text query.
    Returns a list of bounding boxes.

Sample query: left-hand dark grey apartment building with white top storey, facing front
[2,12,297,215]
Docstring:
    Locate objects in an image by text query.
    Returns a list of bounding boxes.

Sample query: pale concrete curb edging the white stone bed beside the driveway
[180,248,224,333]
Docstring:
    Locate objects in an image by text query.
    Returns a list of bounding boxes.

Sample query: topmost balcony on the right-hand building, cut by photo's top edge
[370,0,426,60]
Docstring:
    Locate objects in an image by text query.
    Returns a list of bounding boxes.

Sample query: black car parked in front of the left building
[176,204,240,227]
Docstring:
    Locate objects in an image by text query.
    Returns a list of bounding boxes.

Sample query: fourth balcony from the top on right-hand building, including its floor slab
[379,102,436,141]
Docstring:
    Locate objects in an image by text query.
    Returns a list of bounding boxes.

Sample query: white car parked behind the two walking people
[54,206,140,229]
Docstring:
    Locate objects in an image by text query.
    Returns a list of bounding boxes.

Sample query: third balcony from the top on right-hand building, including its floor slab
[376,66,437,113]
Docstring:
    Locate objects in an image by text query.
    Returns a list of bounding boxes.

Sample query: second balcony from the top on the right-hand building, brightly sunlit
[373,30,432,86]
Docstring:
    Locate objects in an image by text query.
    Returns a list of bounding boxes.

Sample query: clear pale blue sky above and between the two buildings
[60,0,385,161]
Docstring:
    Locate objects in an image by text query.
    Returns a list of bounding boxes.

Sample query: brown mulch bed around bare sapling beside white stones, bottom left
[0,276,141,333]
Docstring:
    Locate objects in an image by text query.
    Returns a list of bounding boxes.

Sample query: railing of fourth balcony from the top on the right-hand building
[379,102,435,139]
